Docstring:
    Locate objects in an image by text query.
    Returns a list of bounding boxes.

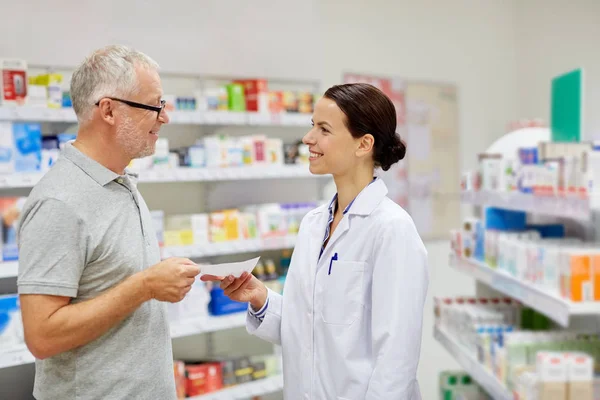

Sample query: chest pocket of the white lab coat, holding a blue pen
[321,260,366,325]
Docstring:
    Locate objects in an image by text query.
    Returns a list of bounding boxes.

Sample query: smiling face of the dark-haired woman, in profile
[302,97,370,176]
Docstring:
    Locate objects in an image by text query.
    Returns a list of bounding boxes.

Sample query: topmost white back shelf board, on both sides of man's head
[0,106,311,127]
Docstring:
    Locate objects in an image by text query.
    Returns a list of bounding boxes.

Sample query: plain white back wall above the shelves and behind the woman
[0,0,520,400]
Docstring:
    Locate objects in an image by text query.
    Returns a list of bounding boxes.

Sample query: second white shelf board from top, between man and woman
[139,164,324,183]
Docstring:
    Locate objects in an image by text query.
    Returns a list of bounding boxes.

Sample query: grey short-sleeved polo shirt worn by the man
[17,144,176,400]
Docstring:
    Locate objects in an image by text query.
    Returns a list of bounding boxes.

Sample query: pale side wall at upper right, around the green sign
[516,0,600,139]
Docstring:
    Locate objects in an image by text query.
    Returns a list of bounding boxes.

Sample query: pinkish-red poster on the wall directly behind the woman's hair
[343,73,410,210]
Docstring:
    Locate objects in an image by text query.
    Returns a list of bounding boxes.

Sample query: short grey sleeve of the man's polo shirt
[17,198,87,297]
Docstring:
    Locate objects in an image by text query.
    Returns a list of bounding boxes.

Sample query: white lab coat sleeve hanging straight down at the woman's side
[365,219,429,400]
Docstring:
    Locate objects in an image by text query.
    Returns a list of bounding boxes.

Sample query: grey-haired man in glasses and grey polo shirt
[18,46,199,400]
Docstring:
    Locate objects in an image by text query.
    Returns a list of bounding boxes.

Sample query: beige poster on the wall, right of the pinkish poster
[406,82,460,239]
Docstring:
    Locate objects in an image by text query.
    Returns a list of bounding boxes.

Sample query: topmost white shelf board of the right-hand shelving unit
[461,190,590,221]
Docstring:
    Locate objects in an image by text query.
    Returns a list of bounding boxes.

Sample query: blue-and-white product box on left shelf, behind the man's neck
[13,123,42,172]
